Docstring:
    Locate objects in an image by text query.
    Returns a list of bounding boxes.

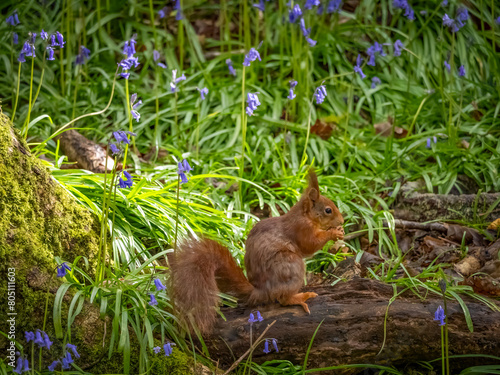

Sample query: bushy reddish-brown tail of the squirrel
[171,238,253,333]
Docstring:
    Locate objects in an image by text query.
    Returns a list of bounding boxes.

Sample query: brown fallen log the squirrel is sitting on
[205,278,500,373]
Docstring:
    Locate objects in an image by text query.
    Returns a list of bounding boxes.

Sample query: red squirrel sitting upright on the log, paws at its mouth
[171,169,344,333]
